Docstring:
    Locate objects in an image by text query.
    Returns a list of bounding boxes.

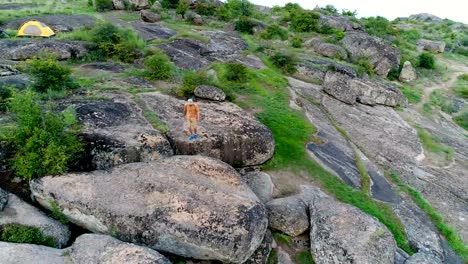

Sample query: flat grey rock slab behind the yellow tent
[1,15,96,32]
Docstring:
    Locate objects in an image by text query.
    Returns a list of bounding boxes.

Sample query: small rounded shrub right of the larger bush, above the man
[145,51,173,80]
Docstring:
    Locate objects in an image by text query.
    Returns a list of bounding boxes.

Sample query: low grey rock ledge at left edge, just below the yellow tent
[0,39,89,61]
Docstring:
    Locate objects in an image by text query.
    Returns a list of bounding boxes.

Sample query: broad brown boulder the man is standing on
[141,93,275,167]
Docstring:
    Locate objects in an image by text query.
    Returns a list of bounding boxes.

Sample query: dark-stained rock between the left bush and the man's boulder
[63,94,173,171]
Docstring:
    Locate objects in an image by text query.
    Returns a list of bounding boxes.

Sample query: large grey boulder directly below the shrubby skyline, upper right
[341,32,401,76]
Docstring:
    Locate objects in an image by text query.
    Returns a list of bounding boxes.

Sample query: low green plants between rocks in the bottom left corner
[0,224,56,247]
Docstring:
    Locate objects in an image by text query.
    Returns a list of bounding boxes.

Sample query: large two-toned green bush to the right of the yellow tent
[90,22,145,62]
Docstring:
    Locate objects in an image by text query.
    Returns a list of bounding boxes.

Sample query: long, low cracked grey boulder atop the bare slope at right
[323,71,407,106]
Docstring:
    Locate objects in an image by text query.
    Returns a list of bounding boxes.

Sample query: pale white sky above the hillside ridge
[250,0,468,24]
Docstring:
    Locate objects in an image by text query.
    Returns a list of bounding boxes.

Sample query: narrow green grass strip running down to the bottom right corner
[387,171,468,263]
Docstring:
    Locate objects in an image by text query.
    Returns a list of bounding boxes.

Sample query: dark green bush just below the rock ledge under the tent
[21,56,76,92]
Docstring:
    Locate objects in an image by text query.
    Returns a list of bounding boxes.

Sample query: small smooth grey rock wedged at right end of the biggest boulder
[242,171,274,203]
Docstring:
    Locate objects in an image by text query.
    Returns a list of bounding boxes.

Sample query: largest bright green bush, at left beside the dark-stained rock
[7,90,82,180]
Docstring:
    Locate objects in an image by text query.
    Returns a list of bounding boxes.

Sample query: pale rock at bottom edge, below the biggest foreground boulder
[68,234,171,264]
